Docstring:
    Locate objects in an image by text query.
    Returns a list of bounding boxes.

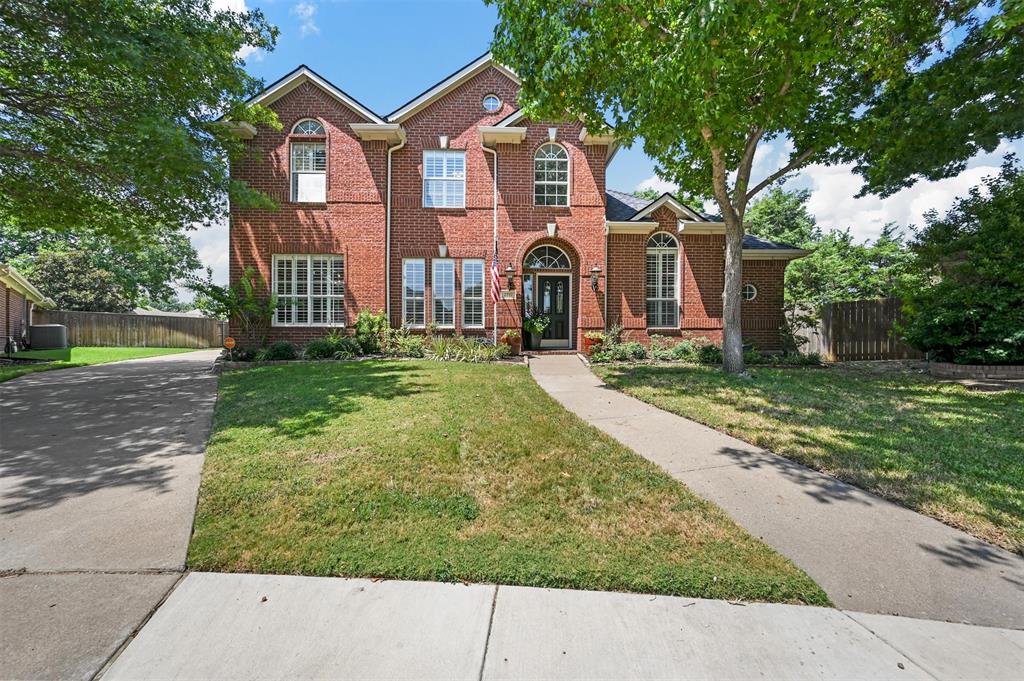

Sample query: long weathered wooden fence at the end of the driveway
[32,309,227,347]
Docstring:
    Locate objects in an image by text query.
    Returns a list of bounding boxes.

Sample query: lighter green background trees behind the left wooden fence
[0,224,201,309]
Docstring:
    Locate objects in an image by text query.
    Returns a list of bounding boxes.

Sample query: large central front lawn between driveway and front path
[188,360,827,603]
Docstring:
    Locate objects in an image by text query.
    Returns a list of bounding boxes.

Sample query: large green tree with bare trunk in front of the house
[489,0,1015,372]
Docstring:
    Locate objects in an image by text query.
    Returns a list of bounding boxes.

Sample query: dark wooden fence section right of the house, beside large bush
[797,298,925,361]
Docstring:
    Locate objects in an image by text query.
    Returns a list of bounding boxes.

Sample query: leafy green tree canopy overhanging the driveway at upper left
[0,0,276,242]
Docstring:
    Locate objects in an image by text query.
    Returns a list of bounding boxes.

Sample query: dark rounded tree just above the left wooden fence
[26,251,132,312]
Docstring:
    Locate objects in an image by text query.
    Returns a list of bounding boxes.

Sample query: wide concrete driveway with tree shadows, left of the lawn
[0,350,217,679]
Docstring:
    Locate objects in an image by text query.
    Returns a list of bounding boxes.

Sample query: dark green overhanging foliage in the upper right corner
[844,0,1024,196]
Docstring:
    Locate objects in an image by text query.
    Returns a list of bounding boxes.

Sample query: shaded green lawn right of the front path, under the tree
[595,366,1024,553]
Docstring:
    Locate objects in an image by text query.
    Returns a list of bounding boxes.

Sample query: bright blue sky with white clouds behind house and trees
[193,0,1024,290]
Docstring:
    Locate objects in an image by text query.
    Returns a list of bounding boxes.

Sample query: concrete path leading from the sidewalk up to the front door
[530,355,1024,629]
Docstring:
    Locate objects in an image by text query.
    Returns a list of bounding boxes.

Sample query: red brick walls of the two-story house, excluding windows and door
[230,58,785,349]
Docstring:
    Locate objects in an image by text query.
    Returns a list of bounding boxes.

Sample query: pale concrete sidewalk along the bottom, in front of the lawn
[102,572,1024,681]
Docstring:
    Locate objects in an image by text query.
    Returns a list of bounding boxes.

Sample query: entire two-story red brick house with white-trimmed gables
[230,53,804,350]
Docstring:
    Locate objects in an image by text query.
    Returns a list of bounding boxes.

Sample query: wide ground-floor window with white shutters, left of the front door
[271,255,345,327]
